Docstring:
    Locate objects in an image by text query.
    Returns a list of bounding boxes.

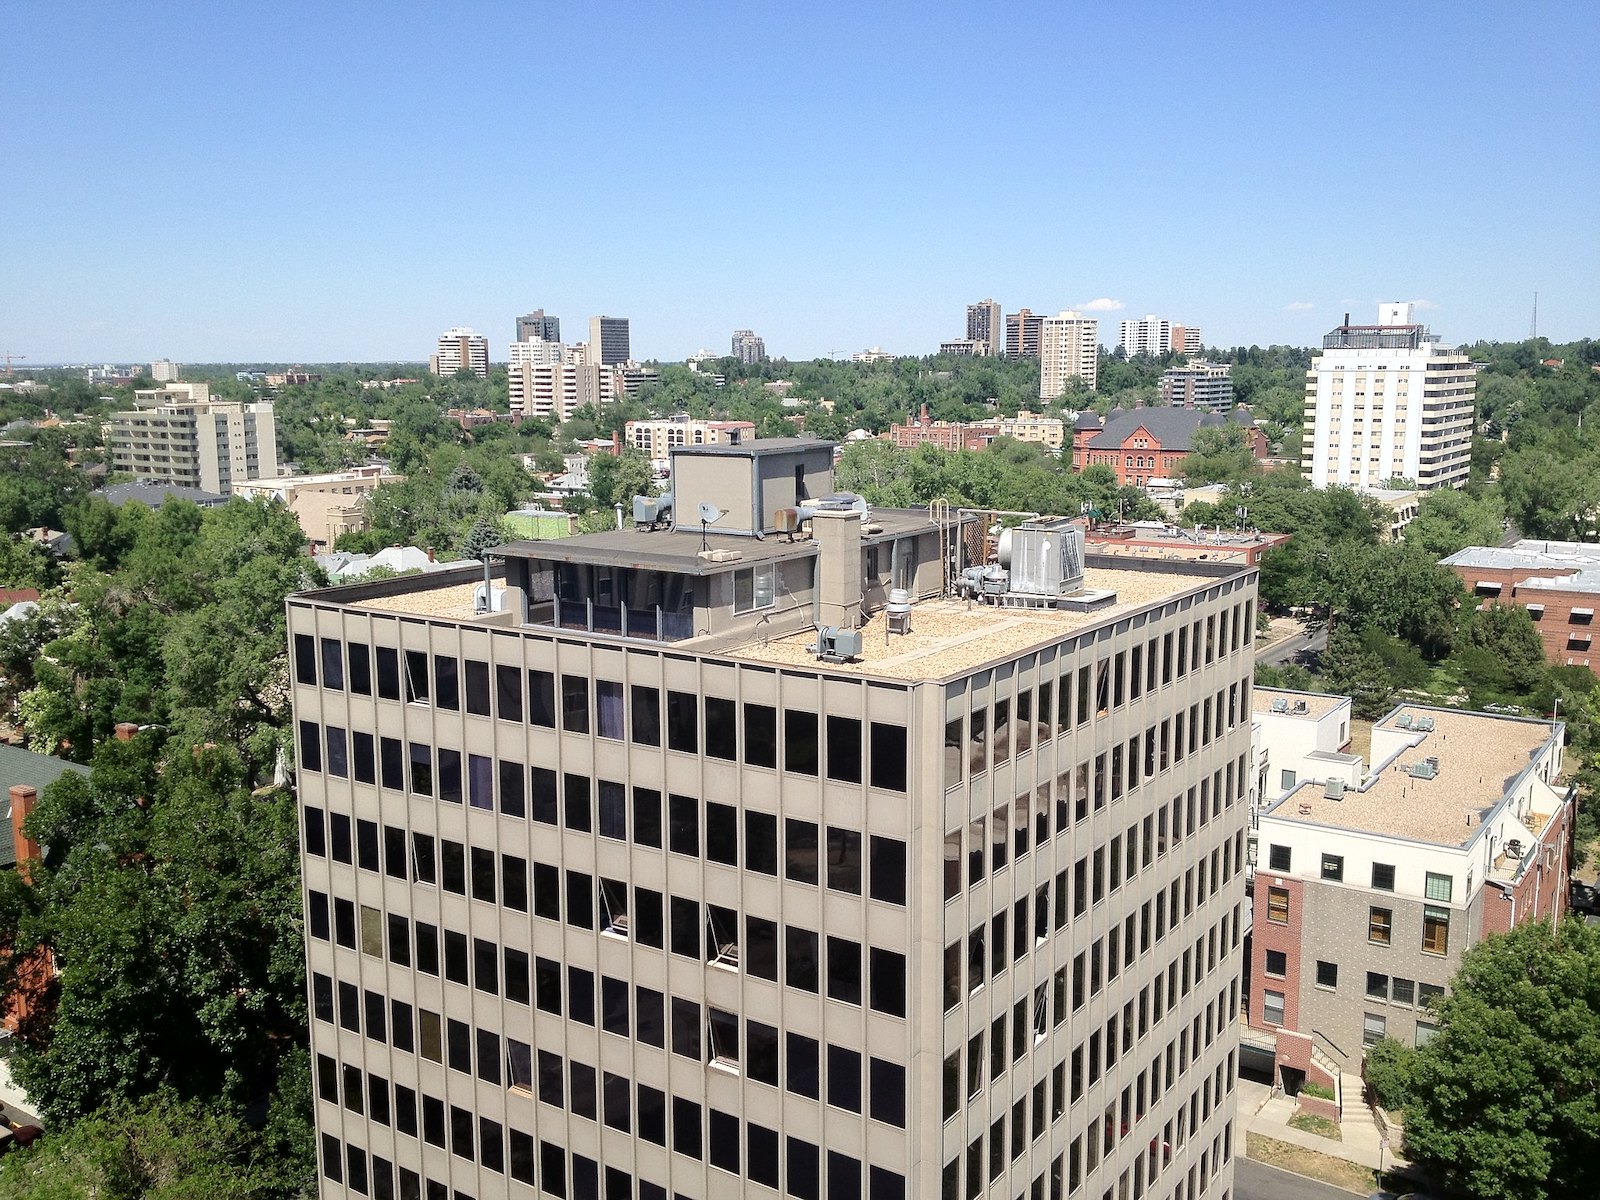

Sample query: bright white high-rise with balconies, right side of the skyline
[1301,304,1477,490]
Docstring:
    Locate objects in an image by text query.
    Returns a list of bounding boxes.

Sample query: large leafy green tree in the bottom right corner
[1405,920,1600,1200]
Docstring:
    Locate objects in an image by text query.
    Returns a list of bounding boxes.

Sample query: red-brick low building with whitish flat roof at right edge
[1440,538,1600,670]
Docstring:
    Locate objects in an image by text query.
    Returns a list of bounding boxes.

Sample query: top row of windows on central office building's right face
[944,600,1254,787]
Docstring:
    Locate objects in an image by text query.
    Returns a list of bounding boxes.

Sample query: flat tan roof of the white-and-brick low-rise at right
[1266,704,1563,846]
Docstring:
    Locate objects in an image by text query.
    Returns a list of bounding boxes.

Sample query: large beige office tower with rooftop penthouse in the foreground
[290,438,1256,1200]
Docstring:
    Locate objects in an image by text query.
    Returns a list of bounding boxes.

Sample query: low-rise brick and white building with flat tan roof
[1245,704,1573,1090]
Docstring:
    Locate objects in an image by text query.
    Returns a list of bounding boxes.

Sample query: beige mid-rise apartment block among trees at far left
[107,384,278,496]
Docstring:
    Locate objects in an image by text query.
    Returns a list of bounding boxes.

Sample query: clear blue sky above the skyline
[0,0,1600,363]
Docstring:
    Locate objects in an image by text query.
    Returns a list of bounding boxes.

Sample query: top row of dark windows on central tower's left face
[294,634,907,792]
